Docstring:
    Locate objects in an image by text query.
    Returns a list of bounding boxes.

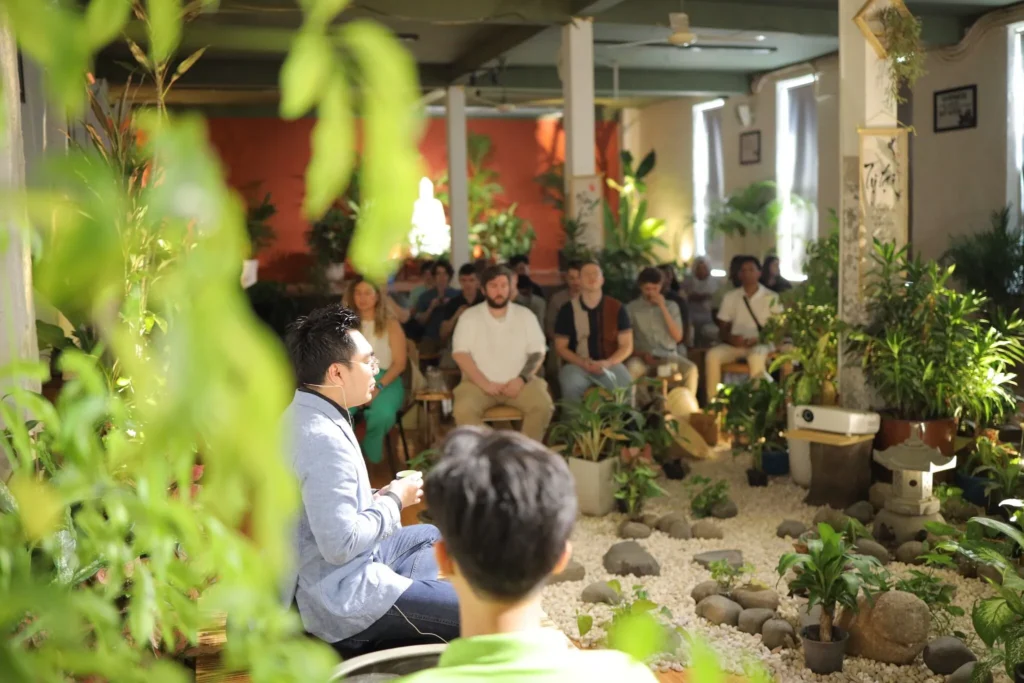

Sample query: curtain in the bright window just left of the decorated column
[778,82,818,276]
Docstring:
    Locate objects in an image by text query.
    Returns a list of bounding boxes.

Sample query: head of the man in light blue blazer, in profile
[286,303,378,408]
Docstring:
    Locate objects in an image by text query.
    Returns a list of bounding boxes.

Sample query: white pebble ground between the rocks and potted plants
[544,455,1008,683]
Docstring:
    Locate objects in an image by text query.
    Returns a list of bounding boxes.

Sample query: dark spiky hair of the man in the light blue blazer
[285,303,359,384]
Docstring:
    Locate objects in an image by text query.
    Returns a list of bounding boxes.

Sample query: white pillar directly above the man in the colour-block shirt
[560,17,604,247]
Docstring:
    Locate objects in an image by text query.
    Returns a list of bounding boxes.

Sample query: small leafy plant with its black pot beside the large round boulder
[777,523,879,674]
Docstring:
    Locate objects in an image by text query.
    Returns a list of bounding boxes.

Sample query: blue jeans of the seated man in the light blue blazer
[334,524,459,657]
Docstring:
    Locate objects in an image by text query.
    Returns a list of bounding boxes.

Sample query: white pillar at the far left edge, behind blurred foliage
[0,18,40,479]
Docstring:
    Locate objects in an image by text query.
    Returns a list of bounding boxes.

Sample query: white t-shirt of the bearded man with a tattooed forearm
[452,303,547,384]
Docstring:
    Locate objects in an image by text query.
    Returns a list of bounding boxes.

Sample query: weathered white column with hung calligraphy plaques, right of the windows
[839,0,909,410]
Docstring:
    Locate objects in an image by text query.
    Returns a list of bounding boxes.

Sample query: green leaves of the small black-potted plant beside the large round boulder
[777,524,879,643]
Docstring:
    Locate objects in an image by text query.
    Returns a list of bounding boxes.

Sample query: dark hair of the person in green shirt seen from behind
[424,427,577,601]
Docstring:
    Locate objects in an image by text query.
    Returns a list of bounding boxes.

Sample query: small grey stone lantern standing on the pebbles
[874,425,956,545]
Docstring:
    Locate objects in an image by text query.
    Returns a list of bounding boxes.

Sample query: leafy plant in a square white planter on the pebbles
[551,389,643,516]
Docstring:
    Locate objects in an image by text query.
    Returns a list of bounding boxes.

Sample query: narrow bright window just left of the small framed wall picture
[693,99,725,274]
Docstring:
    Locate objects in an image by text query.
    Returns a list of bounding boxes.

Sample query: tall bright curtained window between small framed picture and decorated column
[775,74,818,280]
